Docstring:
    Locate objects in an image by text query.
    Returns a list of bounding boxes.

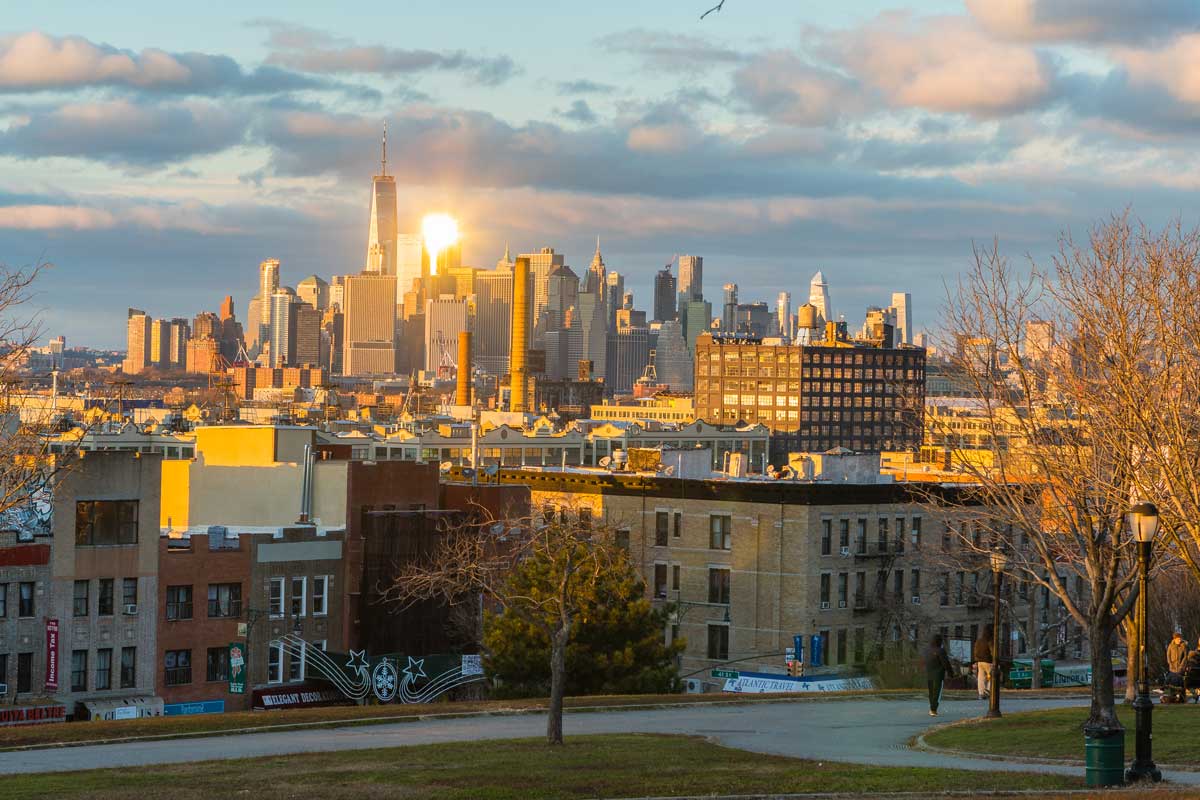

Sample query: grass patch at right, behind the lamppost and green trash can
[925,704,1200,764]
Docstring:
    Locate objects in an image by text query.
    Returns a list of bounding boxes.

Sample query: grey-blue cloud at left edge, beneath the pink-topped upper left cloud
[0,100,250,168]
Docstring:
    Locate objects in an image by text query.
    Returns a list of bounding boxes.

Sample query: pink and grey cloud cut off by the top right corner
[966,0,1200,42]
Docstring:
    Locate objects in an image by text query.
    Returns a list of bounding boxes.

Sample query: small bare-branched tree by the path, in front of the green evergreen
[384,509,617,745]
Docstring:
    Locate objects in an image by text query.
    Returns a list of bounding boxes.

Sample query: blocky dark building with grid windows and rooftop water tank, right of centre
[695,331,925,455]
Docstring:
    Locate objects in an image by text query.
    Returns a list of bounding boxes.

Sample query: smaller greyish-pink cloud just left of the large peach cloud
[732,50,863,126]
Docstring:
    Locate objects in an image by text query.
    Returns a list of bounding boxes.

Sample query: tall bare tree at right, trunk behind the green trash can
[921,216,1166,733]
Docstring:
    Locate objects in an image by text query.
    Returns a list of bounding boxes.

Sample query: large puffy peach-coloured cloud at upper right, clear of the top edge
[822,12,1056,116]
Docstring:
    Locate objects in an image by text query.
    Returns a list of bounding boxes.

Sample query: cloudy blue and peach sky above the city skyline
[0,0,1200,348]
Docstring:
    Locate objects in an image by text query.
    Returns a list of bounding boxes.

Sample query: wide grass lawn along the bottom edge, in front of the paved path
[4,734,1082,800]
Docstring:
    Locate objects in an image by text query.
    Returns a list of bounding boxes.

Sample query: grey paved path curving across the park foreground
[0,698,1200,784]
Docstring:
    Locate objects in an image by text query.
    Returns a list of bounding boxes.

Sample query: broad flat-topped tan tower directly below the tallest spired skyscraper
[342,273,396,375]
